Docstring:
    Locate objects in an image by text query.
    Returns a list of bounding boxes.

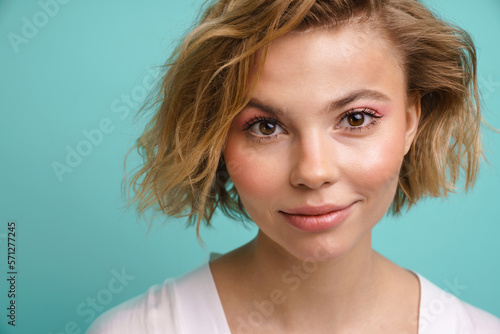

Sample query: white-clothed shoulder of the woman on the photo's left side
[87,263,230,334]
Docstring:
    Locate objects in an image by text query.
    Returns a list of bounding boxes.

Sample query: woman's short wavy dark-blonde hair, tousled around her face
[125,0,482,237]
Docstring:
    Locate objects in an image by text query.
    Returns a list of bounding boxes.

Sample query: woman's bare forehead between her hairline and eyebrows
[250,27,406,109]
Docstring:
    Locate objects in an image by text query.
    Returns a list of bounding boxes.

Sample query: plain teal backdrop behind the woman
[0,0,500,334]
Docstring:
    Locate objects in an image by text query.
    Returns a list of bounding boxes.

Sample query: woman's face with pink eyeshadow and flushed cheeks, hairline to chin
[224,25,419,260]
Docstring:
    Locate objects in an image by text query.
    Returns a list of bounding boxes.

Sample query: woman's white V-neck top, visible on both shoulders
[87,263,500,334]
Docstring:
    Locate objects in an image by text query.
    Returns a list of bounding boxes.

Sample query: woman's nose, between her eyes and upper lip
[290,135,338,189]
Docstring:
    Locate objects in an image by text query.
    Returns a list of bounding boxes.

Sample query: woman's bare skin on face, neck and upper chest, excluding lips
[210,25,420,333]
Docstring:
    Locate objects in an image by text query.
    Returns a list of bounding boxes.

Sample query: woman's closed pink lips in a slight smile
[279,203,354,232]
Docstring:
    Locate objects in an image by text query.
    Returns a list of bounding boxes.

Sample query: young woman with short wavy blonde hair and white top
[89,0,500,333]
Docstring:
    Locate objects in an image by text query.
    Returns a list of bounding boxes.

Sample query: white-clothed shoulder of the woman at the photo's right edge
[417,274,500,334]
